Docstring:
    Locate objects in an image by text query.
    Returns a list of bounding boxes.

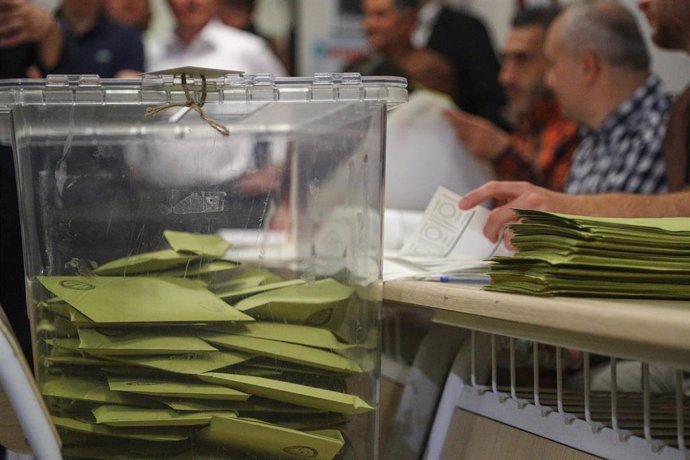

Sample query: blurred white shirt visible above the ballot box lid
[146,19,287,77]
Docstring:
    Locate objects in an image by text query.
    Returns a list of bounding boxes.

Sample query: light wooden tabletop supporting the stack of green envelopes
[383,281,690,368]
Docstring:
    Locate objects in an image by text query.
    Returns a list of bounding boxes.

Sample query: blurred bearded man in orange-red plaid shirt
[446,7,579,191]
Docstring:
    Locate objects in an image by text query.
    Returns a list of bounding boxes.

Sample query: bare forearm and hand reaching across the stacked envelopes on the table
[459,181,690,241]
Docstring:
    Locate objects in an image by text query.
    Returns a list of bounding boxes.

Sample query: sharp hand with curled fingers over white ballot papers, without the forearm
[459,181,574,245]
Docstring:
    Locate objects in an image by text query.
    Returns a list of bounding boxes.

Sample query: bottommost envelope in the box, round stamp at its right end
[197,417,345,460]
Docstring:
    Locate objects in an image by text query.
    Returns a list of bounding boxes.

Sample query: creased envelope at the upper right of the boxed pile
[235,278,353,326]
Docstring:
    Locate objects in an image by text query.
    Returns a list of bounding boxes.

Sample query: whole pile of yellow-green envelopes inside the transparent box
[36,231,373,459]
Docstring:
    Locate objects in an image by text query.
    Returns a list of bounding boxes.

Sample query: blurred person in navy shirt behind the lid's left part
[55,0,144,78]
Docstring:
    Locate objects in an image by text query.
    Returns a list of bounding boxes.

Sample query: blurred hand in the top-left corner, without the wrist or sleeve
[0,0,58,48]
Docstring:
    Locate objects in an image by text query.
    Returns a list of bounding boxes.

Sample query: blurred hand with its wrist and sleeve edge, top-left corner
[0,0,63,69]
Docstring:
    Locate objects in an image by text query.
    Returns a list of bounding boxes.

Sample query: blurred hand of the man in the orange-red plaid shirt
[443,110,510,160]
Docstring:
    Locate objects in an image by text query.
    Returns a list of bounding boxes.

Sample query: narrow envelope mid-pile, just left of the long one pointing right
[108,377,250,401]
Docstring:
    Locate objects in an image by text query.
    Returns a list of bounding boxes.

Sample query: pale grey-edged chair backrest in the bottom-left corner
[0,306,62,460]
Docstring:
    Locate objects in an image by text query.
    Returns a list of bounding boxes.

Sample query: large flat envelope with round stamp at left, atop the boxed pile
[38,276,253,324]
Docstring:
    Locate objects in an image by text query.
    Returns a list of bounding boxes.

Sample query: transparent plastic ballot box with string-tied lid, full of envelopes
[0,74,407,459]
